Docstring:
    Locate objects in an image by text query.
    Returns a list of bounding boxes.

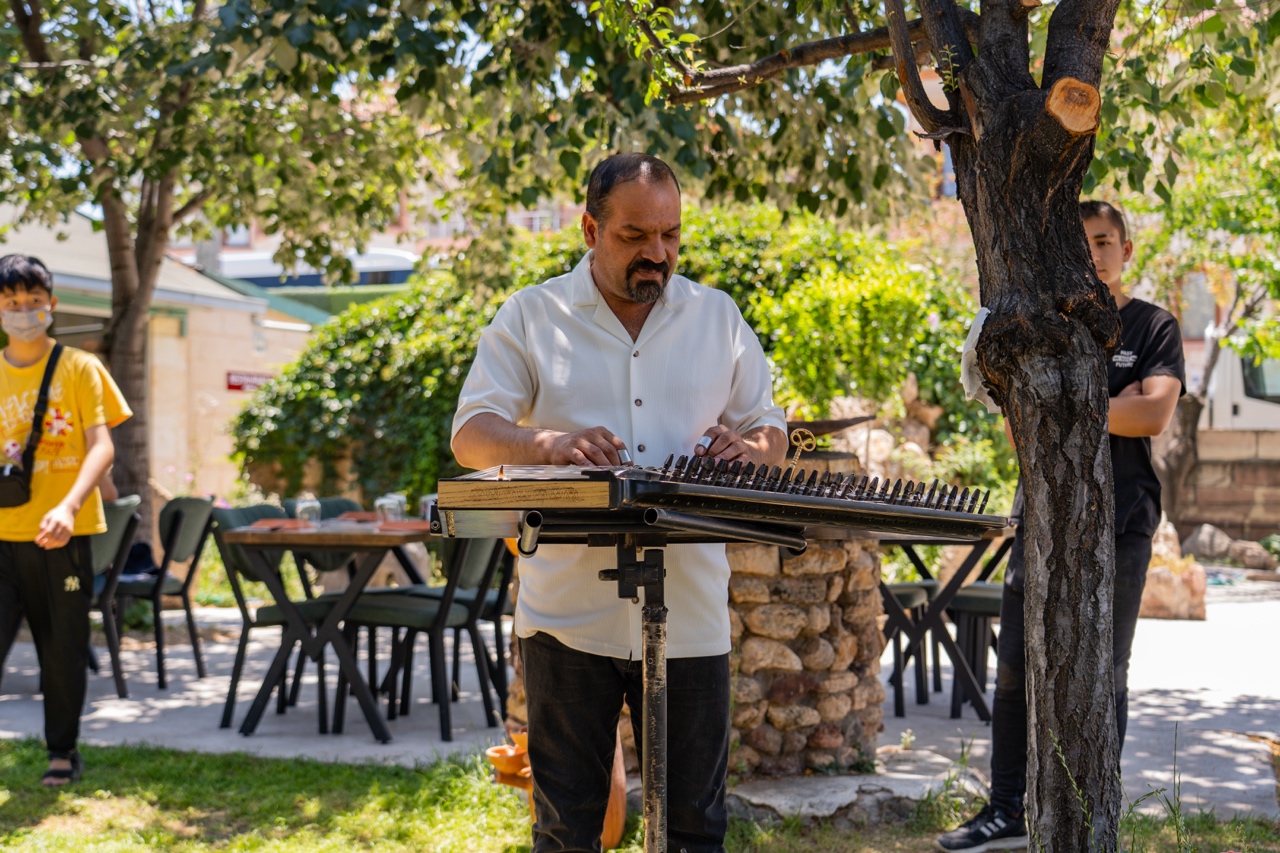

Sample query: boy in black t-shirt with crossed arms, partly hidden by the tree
[937,201,1187,853]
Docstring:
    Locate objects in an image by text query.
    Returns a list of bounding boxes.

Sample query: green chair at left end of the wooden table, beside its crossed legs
[214,503,316,729]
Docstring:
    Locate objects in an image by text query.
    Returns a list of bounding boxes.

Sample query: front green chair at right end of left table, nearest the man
[334,539,507,740]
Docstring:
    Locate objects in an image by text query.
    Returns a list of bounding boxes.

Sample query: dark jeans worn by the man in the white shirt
[520,633,730,853]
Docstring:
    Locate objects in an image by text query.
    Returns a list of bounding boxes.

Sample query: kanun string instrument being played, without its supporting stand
[431,456,1007,556]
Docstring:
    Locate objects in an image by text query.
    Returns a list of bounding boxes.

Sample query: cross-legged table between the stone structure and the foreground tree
[879,528,1016,722]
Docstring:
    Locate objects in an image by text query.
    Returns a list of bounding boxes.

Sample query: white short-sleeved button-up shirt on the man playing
[453,252,786,660]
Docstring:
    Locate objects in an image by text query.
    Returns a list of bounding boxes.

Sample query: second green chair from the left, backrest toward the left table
[115,497,214,690]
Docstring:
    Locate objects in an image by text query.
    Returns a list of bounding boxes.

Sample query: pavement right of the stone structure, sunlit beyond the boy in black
[881,571,1280,818]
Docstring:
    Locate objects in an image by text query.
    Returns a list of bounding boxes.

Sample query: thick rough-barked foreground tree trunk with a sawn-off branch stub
[951,64,1120,853]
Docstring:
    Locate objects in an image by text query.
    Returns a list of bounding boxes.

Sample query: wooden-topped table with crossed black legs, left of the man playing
[223,523,431,743]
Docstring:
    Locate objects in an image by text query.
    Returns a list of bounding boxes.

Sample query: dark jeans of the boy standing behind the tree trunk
[991,528,1151,812]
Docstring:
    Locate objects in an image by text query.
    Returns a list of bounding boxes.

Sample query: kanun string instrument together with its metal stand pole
[430,458,1009,853]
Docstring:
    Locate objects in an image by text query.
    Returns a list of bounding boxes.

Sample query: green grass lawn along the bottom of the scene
[0,740,1280,853]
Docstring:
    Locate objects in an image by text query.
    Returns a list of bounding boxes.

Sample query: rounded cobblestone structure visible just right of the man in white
[728,539,884,777]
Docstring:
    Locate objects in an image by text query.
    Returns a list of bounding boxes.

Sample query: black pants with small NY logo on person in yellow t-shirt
[0,537,93,757]
